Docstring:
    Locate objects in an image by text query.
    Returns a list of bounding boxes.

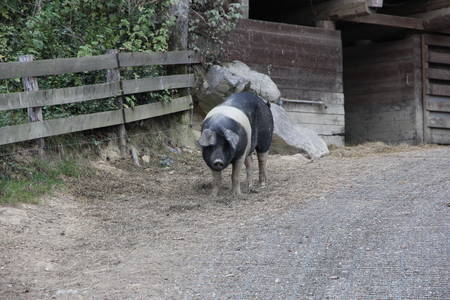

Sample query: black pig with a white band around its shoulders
[198,92,273,195]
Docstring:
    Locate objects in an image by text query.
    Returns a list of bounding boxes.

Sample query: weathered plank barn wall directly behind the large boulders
[225,20,345,145]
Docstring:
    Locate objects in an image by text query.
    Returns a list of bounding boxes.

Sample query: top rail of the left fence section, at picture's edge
[0,54,117,79]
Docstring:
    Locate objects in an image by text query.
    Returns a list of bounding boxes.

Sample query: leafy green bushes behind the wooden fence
[0,0,174,126]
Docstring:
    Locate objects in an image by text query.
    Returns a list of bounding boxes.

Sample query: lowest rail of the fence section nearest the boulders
[125,96,193,123]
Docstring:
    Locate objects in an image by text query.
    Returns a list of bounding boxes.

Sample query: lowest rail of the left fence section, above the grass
[0,110,123,145]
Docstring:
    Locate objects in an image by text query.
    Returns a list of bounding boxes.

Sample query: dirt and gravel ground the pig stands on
[0,146,450,300]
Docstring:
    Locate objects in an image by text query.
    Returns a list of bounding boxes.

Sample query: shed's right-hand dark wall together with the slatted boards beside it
[344,34,450,144]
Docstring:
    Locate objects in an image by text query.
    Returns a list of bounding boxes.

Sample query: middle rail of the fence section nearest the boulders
[122,74,195,95]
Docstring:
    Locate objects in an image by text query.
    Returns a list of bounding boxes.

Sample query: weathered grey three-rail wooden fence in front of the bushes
[0,50,200,149]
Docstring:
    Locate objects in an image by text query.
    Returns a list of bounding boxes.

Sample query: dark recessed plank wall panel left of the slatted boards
[344,36,423,144]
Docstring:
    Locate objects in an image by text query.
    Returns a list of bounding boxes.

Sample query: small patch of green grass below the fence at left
[0,159,82,205]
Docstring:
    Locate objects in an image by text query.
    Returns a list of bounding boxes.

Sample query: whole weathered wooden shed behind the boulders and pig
[232,0,450,145]
